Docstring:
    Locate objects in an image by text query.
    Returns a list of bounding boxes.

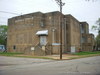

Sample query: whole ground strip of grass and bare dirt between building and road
[0,51,100,60]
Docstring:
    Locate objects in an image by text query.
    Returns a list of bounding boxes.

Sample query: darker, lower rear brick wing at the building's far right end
[80,22,95,51]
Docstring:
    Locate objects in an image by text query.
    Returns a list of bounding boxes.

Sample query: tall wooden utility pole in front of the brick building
[55,0,65,59]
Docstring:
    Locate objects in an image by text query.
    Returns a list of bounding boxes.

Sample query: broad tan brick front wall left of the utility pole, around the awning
[7,12,60,52]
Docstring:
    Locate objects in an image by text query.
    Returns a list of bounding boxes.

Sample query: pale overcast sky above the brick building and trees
[0,0,100,35]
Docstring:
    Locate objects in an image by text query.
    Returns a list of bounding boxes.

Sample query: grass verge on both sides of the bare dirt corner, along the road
[0,51,100,60]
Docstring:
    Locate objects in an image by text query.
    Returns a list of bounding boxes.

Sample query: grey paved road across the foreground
[0,56,100,75]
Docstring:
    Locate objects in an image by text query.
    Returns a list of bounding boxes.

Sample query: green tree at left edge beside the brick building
[0,25,8,46]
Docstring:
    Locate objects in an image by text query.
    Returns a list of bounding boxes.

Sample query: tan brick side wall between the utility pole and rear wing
[66,15,81,52]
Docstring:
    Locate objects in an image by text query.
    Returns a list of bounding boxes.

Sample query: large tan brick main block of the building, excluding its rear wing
[7,11,94,55]
